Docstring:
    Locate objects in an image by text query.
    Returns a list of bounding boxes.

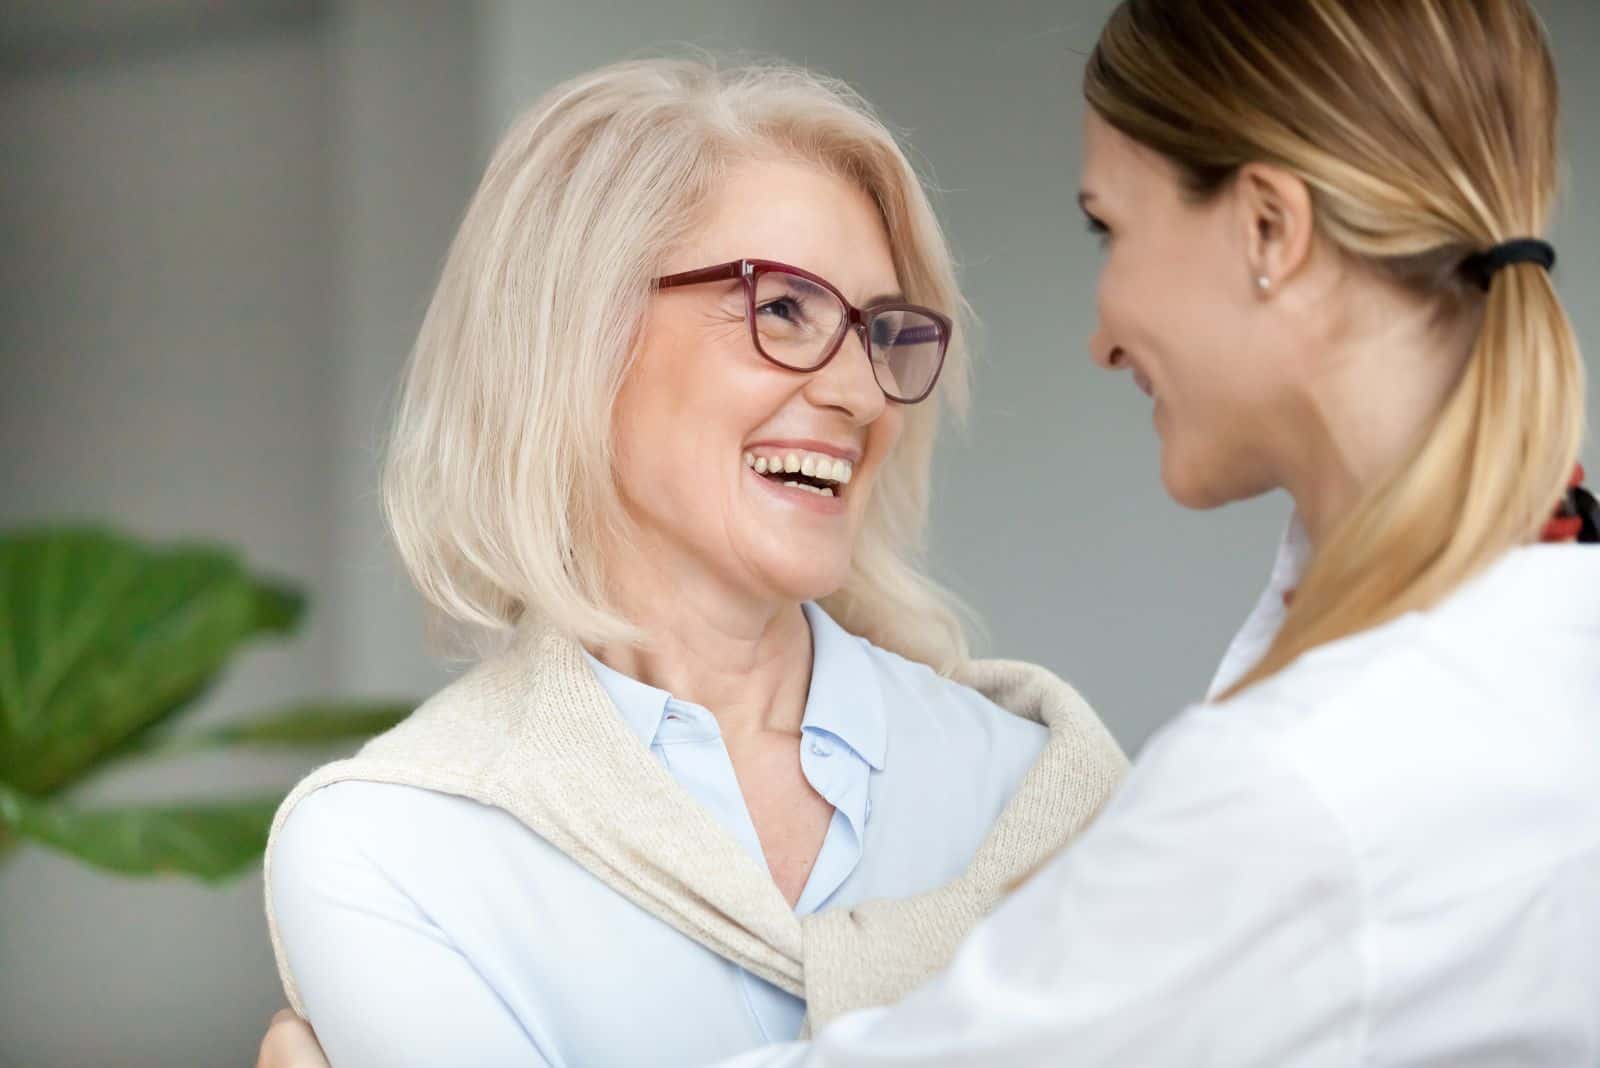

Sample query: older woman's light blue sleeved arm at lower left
[267,790,547,1068]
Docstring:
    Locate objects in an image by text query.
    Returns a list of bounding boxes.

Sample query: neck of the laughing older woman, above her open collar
[590,534,811,740]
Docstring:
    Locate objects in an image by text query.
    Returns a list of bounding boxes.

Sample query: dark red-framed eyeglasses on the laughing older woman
[656,259,950,404]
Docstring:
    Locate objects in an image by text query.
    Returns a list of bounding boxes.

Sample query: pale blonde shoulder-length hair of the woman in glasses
[382,58,968,670]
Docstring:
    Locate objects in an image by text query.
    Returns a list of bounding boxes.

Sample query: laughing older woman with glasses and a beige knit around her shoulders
[267,61,1123,1065]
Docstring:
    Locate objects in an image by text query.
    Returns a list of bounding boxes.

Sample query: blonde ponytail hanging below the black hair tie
[1224,264,1584,699]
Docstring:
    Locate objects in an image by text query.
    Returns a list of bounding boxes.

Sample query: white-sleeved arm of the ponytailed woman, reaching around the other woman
[730,710,1365,1068]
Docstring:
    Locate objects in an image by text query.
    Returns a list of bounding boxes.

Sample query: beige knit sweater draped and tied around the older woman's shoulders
[266,628,1126,1028]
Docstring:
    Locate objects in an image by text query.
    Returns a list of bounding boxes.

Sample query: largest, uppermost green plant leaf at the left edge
[0,528,304,796]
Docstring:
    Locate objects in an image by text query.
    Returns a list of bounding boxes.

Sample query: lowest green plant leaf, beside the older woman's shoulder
[0,787,280,883]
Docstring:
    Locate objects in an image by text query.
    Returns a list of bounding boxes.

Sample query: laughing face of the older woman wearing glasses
[613,154,904,613]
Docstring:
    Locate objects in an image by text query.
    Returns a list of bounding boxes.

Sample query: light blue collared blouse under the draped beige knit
[267,604,1045,1068]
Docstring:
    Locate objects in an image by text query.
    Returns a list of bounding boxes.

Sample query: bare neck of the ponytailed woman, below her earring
[1278,287,1477,547]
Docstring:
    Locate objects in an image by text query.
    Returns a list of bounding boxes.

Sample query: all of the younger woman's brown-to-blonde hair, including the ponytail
[1085,0,1584,692]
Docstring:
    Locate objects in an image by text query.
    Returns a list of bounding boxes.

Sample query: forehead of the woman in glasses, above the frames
[669,160,896,299]
